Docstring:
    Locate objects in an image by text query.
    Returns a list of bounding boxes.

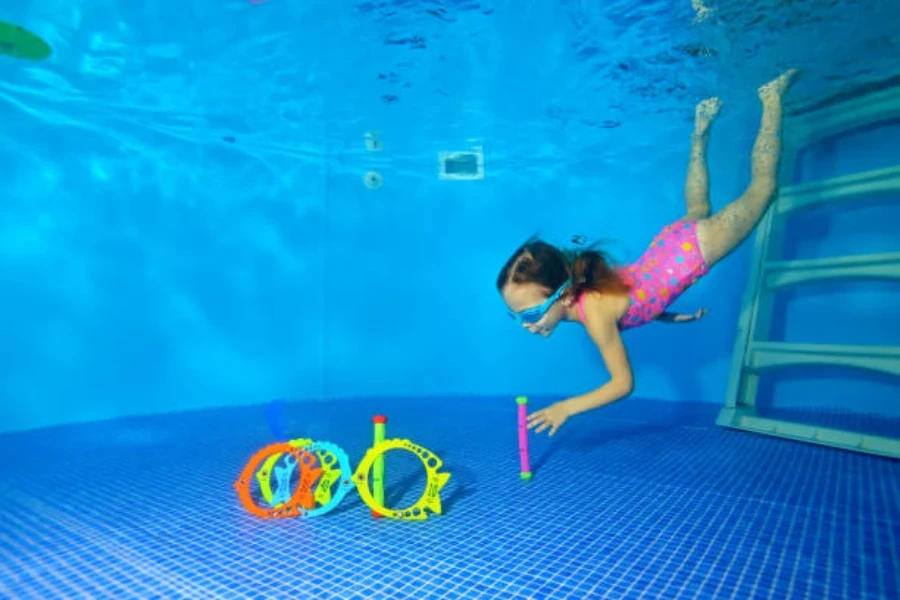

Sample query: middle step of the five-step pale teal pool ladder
[763,252,900,290]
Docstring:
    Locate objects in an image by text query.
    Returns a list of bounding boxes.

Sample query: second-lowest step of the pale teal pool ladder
[745,342,900,376]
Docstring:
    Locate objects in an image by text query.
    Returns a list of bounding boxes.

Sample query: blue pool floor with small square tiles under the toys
[0,398,900,600]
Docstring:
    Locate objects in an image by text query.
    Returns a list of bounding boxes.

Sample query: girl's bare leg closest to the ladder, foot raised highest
[697,70,797,267]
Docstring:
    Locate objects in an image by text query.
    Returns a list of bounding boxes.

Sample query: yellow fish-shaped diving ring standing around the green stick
[353,438,450,521]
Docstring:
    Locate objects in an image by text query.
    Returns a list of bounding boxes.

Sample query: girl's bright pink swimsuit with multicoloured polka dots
[578,221,709,330]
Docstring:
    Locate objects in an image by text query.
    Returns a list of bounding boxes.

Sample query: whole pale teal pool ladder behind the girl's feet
[717,85,900,458]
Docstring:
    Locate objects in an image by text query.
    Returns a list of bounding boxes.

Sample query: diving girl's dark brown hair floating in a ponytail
[497,238,630,298]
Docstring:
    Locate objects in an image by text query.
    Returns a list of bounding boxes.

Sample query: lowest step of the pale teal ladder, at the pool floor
[716,408,900,458]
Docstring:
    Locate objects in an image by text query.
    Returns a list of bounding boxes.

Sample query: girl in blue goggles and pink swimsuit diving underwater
[497,70,797,435]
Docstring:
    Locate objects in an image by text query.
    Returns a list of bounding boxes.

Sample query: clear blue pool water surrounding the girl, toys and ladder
[0,0,900,599]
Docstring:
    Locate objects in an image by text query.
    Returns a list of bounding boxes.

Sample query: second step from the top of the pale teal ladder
[775,166,900,216]
